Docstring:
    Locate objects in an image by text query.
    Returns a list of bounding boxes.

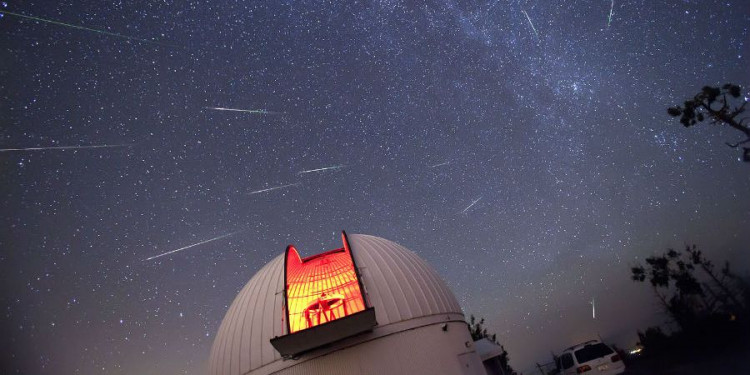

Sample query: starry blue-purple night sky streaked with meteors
[0,0,750,374]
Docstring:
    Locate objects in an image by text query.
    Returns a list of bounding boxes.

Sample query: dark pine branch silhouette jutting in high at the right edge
[667,83,750,162]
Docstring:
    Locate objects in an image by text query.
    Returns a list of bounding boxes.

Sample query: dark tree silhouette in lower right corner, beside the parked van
[630,245,750,362]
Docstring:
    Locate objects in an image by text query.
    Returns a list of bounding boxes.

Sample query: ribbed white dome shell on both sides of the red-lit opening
[209,234,463,375]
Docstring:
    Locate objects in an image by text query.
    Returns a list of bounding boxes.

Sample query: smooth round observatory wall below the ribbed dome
[268,322,485,375]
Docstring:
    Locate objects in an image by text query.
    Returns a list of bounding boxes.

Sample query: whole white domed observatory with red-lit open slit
[209,232,485,375]
